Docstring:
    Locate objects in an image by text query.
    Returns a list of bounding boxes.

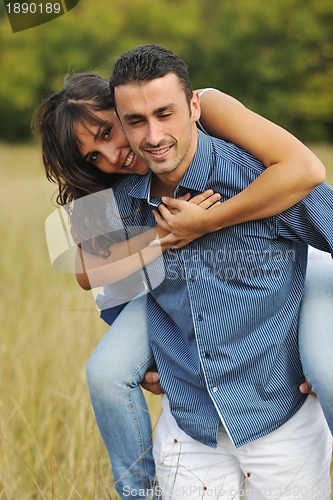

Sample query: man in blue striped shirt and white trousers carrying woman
[110,45,333,500]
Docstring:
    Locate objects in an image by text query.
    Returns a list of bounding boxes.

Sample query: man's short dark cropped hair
[110,44,193,106]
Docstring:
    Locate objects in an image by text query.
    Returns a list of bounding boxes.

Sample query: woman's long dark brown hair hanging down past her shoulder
[34,73,126,257]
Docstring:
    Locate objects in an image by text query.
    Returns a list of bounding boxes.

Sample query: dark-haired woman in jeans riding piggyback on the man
[38,75,330,498]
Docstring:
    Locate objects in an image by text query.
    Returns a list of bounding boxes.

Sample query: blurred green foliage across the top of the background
[0,0,333,141]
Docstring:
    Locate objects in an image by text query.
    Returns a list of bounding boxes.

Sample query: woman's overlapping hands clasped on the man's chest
[153,189,221,248]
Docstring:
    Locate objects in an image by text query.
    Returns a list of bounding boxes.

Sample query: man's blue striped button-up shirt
[110,132,333,447]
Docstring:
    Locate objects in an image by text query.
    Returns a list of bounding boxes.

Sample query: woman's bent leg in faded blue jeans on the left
[87,297,155,498]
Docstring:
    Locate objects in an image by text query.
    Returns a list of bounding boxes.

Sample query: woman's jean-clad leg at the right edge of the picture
[299,259,333,433]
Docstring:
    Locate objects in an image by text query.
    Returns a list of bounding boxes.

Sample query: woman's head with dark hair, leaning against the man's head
[36,73,147,205]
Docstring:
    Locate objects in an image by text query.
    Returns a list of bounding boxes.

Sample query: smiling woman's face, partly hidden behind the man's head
[75,109,148,175]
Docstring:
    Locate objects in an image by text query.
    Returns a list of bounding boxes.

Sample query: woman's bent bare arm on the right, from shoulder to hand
[155,89,325,248]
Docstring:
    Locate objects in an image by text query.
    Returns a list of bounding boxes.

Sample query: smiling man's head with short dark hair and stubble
[110,45,200,181]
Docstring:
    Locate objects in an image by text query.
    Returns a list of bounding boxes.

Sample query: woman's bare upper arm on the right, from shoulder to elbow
[198,89,326,185]
